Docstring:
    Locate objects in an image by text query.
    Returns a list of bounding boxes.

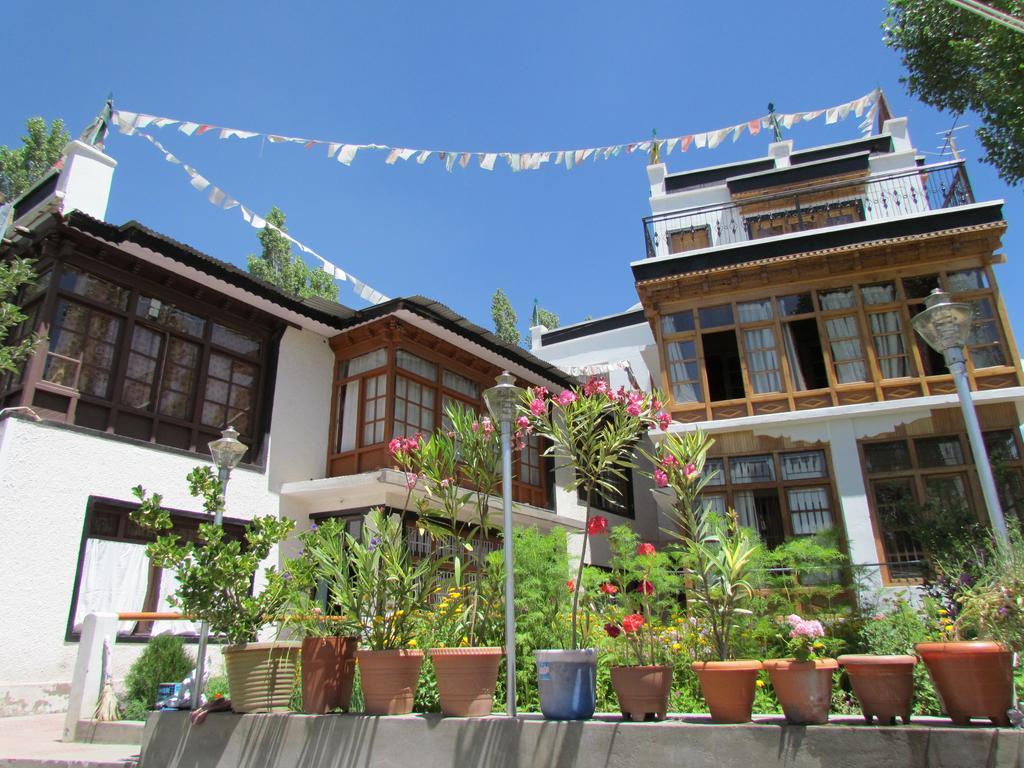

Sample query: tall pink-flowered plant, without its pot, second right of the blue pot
[650,430,761,660]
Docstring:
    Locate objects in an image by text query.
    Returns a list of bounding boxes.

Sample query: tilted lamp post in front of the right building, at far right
[910,288,1007,544]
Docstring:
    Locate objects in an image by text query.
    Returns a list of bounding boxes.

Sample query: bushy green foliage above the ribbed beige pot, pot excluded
[131,466,295,643]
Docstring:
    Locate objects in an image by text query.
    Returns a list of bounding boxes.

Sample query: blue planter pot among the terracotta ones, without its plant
[534,648,597,720]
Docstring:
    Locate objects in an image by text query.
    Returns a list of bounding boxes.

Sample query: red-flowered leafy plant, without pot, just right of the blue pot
[599,525,679,667]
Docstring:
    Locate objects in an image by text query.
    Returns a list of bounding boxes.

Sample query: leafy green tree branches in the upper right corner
[882,0,1024,185]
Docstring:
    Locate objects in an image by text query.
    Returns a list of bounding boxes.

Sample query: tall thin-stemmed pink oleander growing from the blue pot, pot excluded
[516,379,671,648]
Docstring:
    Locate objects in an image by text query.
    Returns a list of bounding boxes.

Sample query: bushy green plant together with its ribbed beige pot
[131,467,299,712]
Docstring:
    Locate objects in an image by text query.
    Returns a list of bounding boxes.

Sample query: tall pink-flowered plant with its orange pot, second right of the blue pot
[651,430,762,723]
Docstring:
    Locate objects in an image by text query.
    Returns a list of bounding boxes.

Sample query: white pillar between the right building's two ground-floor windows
[828,419,882,591]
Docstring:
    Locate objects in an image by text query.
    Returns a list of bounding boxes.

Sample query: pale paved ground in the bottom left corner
[0,714,139,768]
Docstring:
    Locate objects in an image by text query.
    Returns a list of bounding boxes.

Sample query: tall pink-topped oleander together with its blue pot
[516,379,671,720]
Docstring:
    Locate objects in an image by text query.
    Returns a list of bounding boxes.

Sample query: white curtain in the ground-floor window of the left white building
[74,539,150,632]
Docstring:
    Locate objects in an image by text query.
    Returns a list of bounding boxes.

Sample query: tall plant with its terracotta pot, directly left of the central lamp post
[390,404,503,717]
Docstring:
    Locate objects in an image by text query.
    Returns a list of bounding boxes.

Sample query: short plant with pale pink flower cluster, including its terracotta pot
[764,613,839,725]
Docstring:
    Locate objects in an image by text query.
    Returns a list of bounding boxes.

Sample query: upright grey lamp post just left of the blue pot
[483,371,523,717]
